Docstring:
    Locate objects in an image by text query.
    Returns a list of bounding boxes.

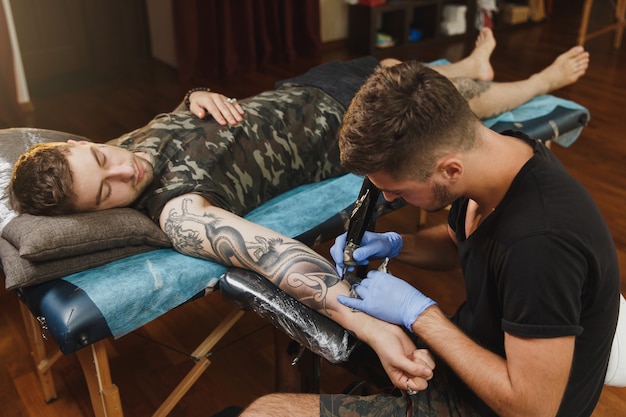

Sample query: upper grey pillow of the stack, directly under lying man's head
[2,208,171,261]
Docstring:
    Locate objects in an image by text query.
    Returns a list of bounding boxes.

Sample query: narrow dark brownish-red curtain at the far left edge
[0,4,20,124]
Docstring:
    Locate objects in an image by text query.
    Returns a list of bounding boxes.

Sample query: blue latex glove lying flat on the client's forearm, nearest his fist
[337,271,437,332]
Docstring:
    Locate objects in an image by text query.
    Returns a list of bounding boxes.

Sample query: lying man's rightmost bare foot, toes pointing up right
[533,45,589,94]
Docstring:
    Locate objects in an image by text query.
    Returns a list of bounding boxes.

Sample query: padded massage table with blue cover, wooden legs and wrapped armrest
[0,95,589,417]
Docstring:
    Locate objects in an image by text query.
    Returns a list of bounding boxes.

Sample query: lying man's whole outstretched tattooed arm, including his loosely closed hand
[160,194,432,389]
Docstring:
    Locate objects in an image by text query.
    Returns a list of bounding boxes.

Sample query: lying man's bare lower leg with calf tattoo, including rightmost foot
[451,46,589,119]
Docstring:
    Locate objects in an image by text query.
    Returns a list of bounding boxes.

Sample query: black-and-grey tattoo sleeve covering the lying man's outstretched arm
[165,199,340,314]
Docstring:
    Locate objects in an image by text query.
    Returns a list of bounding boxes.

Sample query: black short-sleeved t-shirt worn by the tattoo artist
[449,134,620,417]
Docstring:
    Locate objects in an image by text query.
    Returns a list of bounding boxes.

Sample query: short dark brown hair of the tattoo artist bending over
[339,61,480,181]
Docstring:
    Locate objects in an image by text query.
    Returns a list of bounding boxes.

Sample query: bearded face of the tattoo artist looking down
[368,171,459,212]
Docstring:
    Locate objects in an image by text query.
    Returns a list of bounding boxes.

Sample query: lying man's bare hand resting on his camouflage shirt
[189,91,244,126]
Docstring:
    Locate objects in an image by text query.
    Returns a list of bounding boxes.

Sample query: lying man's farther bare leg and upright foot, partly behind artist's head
[380,28,496,81]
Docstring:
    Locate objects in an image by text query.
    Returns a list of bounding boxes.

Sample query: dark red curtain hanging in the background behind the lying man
[173,0,322,81]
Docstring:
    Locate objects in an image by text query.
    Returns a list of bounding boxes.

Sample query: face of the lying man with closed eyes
[67,142,154,211]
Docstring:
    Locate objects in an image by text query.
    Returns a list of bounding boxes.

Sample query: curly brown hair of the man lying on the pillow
[9,142,77,216]
